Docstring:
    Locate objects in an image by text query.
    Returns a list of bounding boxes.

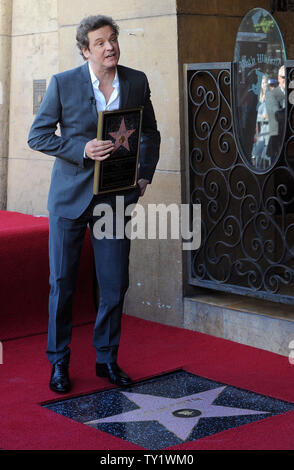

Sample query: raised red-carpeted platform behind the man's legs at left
[0,211,95,340]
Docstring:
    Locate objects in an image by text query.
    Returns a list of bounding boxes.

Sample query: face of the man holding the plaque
[83,26,120,72]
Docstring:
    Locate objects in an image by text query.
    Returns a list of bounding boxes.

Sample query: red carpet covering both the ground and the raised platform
[0,212,294,450]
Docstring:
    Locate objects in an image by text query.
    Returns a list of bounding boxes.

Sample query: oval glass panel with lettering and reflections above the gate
[233,8,286,172]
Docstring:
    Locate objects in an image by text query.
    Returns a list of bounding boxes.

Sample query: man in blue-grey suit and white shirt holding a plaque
[28,15,160,393]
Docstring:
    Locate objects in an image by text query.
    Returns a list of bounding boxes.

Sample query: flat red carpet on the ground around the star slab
[0,315,294,450]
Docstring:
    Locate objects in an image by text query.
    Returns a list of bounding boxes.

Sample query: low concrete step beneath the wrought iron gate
[184,292,294,357]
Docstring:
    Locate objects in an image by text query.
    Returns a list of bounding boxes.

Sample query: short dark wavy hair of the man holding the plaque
[76,15,119,60]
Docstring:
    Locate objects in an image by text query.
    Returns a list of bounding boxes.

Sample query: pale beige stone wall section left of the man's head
[7,0,59,215]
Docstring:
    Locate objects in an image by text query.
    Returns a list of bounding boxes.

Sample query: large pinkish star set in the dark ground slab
[84,386,267,441]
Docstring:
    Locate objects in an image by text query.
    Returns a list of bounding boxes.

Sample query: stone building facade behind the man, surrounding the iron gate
[0,0,294,355]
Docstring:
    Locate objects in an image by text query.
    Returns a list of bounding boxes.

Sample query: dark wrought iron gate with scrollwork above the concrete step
[184,61,294,304]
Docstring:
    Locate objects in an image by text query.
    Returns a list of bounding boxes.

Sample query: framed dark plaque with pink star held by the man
[93,106,143,194]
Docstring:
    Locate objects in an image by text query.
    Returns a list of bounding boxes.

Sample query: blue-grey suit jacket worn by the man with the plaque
[28,63,160,219]
